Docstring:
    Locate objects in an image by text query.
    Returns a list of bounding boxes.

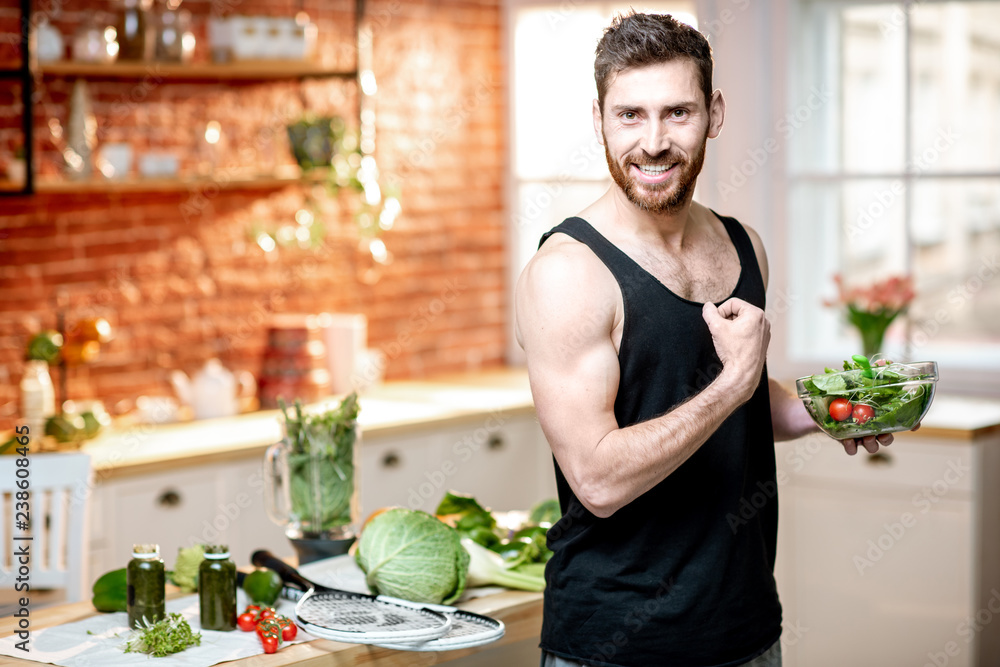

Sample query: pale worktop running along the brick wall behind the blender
[82,368,534,480]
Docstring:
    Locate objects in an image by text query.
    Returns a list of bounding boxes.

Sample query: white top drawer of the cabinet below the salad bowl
[775,434,977,497]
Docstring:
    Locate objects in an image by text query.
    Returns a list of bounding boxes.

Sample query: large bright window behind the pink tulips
[787,0,1000,380]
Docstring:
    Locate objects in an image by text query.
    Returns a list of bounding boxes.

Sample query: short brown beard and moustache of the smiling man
[602,130,708,213]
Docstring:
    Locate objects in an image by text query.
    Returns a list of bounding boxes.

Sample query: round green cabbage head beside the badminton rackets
[355,507,469,604]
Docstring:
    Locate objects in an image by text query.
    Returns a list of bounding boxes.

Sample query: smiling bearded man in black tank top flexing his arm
[515,14,892,667]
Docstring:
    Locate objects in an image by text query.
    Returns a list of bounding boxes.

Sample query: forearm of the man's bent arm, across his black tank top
[577,376,746,517]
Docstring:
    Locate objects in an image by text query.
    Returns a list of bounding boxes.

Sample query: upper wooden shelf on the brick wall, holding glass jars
[38,60,357,81]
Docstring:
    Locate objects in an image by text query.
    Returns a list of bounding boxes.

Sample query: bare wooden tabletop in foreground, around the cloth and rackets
[0,591,542,667]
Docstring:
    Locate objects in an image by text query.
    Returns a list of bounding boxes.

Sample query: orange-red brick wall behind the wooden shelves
[0,0,506,428]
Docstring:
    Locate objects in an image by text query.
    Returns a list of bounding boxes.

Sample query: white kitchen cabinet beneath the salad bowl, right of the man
[775,433,1000,667]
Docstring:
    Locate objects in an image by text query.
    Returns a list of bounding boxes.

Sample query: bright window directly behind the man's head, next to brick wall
[507,0,697,362]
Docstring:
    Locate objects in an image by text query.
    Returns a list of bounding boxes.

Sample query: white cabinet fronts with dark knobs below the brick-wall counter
[90,404,555,580]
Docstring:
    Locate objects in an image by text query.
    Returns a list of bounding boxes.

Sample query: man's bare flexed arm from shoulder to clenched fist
[515,243,770,517]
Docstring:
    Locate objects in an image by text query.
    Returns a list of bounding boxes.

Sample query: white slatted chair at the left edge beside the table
[0,452,93,602]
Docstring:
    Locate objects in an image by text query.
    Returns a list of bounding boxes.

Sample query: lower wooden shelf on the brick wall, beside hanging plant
[35,173,325,195]
